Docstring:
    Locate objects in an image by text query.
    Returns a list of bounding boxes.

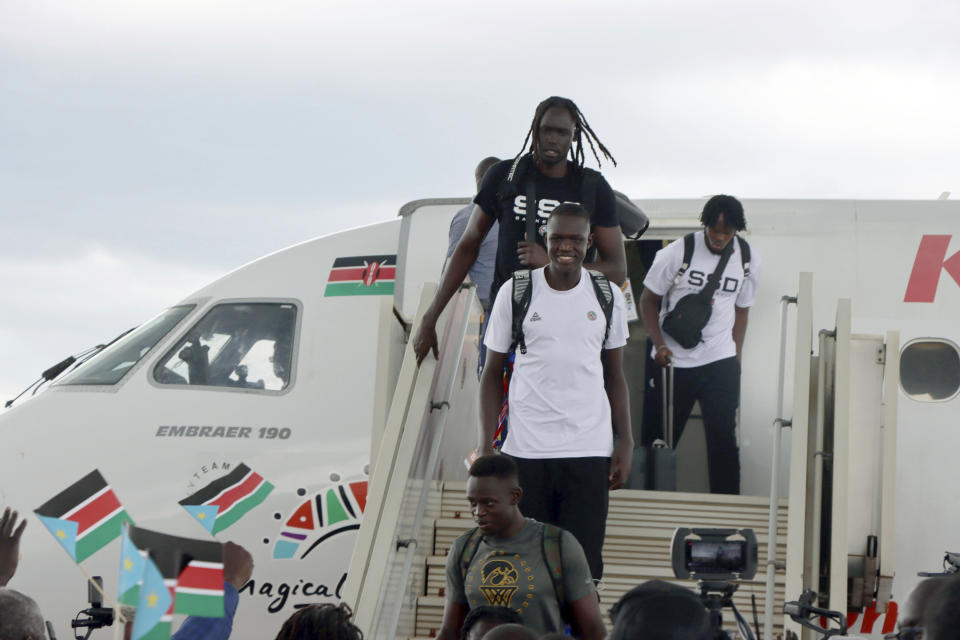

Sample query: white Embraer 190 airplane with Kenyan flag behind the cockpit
[0,198,960,638]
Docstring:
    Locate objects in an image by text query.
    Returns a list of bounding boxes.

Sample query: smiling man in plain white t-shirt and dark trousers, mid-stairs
[478,202,633,580]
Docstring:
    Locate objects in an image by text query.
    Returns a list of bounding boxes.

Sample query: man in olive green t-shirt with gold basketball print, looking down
[437,455,606,640]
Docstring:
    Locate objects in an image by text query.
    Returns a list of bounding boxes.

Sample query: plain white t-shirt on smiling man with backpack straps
[483,269,627,458]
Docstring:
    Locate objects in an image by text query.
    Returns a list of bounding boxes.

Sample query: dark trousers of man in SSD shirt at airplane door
[641,357,740,494]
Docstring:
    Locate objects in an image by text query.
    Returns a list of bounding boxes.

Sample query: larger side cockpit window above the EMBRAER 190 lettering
[153,303,297,391]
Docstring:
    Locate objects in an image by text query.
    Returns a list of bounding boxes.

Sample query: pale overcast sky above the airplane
[0,0,960,400]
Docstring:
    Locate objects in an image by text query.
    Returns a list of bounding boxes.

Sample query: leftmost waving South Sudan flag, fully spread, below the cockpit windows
[33,470,133,562]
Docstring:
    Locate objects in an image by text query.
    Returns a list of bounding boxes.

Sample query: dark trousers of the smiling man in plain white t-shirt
[502,456,610,580]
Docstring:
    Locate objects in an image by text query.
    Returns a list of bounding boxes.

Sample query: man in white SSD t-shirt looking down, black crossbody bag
[640,195,760,494]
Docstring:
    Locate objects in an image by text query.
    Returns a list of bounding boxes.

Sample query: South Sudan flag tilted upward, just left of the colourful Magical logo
[180,463,273,535]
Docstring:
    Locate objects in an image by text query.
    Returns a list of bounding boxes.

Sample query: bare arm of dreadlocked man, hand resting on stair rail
[413,206,493,364]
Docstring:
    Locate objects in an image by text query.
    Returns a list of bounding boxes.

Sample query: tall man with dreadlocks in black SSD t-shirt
[413,96,627,363]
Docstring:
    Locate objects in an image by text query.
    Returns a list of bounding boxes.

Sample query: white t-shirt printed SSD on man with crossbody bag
[643,231,760,368]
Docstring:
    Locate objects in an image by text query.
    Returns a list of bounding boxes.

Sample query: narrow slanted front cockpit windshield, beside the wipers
[59,304,195,385]
